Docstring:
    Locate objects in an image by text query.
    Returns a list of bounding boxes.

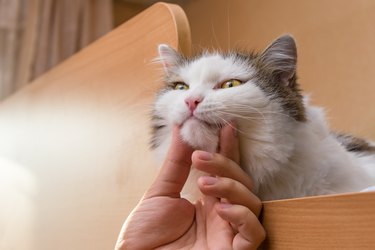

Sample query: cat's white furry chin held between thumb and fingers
[181,118,219,152]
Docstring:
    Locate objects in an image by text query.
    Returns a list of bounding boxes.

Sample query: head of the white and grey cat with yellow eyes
[153,37,306,151]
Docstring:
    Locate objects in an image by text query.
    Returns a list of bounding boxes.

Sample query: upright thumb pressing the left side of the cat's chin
[145,126,193,198]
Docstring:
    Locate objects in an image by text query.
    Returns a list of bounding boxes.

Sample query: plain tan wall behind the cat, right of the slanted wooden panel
[182,0,375,139]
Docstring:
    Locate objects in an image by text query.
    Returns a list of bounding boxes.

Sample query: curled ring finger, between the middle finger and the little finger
[198,176,262,217]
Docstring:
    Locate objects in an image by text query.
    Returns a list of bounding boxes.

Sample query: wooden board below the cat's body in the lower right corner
[263,192,375,250]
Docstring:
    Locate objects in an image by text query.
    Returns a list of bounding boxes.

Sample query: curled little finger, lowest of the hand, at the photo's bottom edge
[216,203,266,249]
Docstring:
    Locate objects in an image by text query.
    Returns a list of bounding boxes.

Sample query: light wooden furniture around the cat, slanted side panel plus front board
[0,3,375,250]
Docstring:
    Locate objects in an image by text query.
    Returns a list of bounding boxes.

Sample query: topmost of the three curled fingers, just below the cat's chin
[191,150,253,190]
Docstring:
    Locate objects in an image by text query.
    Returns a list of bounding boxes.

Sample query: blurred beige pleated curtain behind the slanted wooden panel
[0,0,113,100]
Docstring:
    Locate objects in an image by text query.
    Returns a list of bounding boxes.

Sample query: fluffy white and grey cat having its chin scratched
[152,35,375,201]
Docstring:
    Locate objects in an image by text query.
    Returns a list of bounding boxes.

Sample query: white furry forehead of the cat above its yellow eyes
[179,54,254,84]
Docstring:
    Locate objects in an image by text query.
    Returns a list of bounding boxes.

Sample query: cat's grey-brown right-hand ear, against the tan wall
[259,35,297,86]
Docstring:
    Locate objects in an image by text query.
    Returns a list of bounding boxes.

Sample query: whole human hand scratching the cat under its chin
[116,126,265,250]
